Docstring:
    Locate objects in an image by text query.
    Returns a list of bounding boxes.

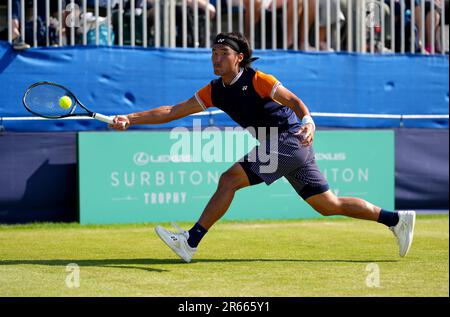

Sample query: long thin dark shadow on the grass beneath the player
[0,259,398,273]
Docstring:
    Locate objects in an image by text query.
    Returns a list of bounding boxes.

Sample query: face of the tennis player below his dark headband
[211,44,243,76]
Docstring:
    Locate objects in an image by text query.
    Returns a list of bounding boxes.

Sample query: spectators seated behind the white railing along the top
[0,0,449,53]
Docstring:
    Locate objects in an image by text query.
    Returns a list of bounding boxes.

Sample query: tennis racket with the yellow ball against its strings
[22,81,121,124]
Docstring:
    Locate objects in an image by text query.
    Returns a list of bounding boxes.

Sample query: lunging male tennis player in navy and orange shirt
[111,32,415,262]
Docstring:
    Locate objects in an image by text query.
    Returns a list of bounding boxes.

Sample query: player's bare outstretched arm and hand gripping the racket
[110,97,203,130]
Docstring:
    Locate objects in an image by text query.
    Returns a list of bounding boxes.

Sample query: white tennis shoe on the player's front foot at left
[155,223,197,263]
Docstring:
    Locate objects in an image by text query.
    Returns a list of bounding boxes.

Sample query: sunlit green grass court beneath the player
[0,215,449,297]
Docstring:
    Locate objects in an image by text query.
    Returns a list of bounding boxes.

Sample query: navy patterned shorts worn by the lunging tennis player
[239,132,329,199]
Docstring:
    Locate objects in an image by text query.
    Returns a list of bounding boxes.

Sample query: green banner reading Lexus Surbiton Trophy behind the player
[78,128,394,224]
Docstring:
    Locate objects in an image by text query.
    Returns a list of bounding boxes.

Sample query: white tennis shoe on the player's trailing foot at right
[389,210,416,257]
